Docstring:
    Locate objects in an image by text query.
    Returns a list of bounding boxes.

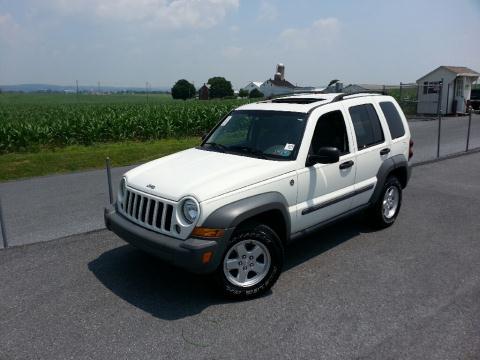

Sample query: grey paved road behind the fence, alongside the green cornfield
[0,115,480,247]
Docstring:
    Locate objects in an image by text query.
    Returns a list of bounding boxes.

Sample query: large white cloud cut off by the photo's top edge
[47,0,239,29]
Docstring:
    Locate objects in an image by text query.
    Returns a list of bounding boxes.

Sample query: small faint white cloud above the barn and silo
[280,17,341,48]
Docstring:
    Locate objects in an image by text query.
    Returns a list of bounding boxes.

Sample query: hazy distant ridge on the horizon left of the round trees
[0,84,171,92]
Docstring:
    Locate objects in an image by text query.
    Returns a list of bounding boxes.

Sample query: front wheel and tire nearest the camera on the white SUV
[215,224,284,300]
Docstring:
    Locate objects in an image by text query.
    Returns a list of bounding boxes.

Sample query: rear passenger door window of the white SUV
[348,104,385,150]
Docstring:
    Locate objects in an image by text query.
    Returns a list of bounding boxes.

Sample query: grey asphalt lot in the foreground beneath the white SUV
[0,153,480,360]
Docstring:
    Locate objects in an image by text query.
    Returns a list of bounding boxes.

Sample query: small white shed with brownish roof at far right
[417,66,480,114]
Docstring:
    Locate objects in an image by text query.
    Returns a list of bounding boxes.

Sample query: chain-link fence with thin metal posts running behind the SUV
[0,83,480,249]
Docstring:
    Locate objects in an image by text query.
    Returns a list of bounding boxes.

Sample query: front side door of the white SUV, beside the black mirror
[292,110,356,231]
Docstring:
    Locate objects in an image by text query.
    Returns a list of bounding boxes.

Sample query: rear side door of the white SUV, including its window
[345,98,391,208]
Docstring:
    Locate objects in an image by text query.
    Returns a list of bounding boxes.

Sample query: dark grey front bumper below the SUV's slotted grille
[104,207,233,273]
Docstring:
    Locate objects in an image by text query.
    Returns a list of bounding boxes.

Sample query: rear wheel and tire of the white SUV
[370,176,402,229]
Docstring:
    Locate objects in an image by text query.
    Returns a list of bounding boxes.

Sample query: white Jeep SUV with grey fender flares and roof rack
[105,94,412,298]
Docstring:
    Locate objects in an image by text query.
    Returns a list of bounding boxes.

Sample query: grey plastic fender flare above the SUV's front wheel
[202,192,291,239]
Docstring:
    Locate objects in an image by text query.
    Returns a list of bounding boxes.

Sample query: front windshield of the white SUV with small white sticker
[201,110,307,160]
